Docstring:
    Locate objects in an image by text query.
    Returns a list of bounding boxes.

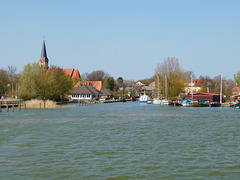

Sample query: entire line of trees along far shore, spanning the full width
[0,57,240,101]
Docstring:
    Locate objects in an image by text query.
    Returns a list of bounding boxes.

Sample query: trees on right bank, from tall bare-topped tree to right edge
[154,57,240,98]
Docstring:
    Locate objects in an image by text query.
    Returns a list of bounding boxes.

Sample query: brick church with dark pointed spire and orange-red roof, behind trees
[39,40,81,79]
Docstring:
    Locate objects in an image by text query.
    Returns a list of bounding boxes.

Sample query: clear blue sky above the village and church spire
[0,0,240,80]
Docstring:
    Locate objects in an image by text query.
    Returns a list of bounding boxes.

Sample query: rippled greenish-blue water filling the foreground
[0,102,240,180]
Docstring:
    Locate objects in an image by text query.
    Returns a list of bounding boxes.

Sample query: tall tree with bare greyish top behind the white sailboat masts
[155,57,190,97]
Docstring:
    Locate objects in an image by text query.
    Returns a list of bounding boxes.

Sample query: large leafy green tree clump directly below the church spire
[19,63,73,101]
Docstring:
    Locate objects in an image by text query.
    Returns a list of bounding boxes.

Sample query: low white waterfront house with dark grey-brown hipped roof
[69,85,103,101]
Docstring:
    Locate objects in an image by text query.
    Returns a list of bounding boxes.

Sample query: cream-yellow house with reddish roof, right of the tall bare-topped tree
[184,79,203,94]
